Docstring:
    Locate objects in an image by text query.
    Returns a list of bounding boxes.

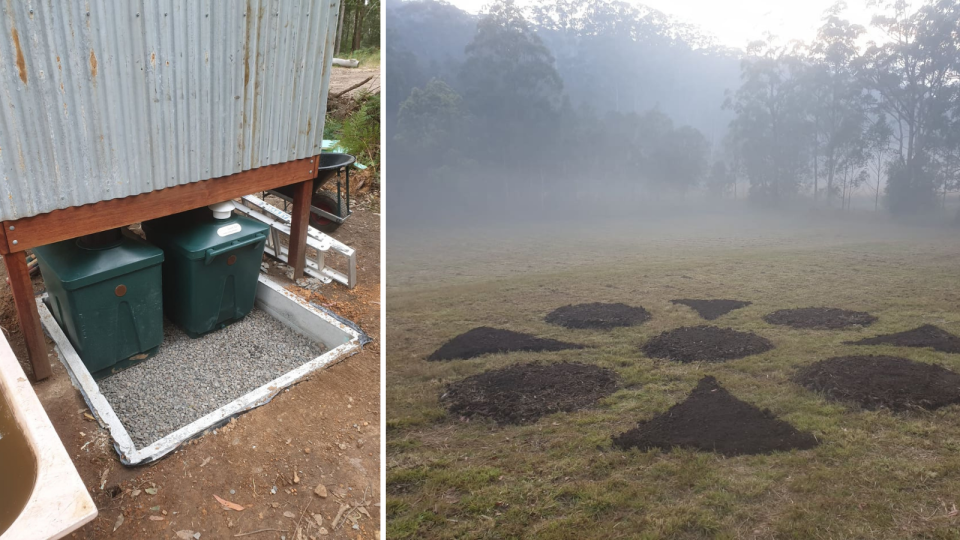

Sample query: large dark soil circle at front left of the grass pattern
[441,363,618,424]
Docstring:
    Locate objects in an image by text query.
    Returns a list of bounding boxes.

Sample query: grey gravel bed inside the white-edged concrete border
[100,308,324,448]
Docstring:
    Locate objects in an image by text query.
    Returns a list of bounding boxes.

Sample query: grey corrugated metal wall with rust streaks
[0,0,340,220]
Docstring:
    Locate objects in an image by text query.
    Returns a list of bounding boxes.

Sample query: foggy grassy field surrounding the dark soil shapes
[387,209,960,539]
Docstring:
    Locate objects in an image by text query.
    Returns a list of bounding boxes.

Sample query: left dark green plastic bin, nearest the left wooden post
[33,229,163,379]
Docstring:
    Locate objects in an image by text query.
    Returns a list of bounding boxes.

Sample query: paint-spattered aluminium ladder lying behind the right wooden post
[233,195,357,289]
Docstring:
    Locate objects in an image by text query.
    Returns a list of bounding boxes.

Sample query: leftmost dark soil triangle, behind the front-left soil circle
[427,326,583,361]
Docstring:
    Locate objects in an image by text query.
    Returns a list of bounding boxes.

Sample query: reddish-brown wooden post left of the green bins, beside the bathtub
[3,251,52,381]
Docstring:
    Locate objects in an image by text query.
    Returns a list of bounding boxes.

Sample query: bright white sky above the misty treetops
[448,0,892,49]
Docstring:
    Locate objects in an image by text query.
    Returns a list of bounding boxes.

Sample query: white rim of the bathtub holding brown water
[0,335,97,540]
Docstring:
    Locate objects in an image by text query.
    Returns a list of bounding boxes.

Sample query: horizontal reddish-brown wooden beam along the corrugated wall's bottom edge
[0,157,317,252]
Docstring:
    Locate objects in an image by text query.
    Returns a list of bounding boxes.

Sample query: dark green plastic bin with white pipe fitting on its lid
[142,202,269,337]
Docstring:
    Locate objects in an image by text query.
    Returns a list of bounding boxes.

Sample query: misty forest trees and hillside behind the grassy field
[385,0,960,214]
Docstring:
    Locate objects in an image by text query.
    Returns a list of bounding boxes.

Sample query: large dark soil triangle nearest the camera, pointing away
[613,376,818,456]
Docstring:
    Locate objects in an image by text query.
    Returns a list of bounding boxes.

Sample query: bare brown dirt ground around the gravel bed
[0,205,382,540]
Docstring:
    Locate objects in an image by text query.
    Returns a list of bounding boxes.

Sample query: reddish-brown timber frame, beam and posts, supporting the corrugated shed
[0,156,319,380]
